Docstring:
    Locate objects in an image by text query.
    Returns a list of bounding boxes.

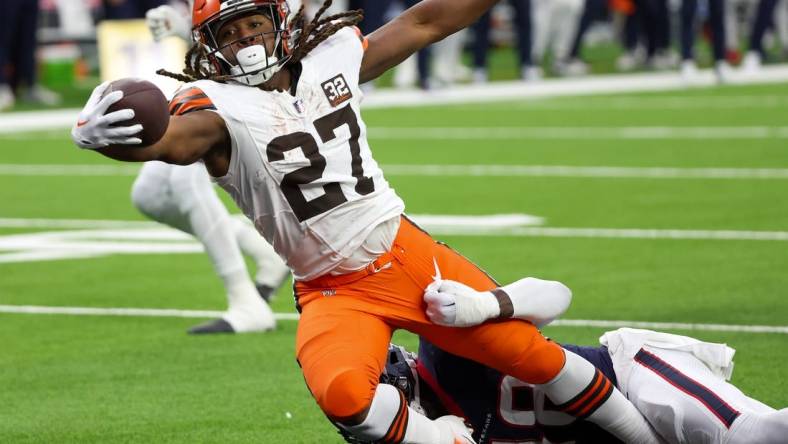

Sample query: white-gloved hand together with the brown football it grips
[71,78,170,149]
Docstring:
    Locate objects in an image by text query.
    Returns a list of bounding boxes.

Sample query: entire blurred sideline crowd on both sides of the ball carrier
[0,0,788,110]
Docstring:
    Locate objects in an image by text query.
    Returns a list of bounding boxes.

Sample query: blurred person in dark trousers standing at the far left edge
[0,0,60,111]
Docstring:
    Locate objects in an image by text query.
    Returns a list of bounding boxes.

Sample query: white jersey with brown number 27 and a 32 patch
[171,28,404,280]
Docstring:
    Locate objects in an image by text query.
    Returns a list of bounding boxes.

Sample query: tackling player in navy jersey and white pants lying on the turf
[412,278,788,444]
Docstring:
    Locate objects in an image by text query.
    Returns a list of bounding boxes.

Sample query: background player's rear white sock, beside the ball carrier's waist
[231,217,290,288]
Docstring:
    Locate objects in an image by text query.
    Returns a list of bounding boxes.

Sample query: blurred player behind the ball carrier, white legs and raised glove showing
[141,0,289,334]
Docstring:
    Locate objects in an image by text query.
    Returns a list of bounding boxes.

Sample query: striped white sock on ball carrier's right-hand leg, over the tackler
[538,350,660,444]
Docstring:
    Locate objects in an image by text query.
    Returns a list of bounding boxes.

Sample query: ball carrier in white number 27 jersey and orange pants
[72,0,659,444]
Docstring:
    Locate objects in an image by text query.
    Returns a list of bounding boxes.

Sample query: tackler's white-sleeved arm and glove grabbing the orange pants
[424,277,572,328]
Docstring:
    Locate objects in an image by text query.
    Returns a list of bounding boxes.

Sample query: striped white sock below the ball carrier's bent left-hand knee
[340,384,454,444]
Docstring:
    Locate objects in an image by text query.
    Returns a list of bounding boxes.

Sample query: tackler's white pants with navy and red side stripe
[600,328,788,444]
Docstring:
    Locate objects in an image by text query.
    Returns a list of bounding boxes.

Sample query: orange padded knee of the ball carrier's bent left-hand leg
[313,369,377,423]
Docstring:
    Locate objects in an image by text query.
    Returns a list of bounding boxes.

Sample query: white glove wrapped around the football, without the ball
[71,82,142,150]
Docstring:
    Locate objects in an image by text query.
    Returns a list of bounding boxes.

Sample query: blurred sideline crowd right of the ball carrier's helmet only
[340,0,788,88]
